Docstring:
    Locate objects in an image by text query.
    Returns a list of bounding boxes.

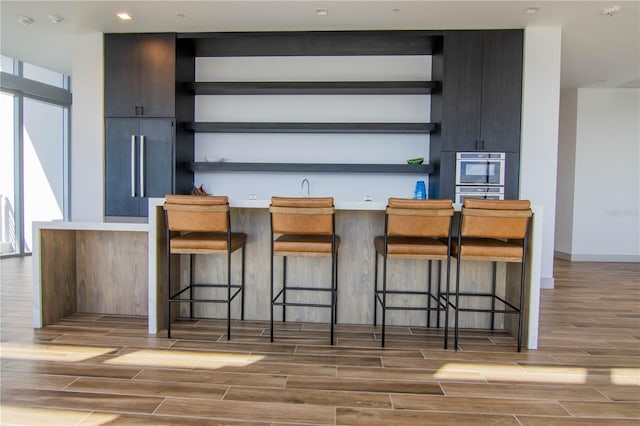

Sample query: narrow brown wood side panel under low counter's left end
[40,229,77,326]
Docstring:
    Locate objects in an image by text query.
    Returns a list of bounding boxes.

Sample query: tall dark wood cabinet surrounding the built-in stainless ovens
[429,30,523,198]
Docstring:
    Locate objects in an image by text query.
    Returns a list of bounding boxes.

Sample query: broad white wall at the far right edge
[571,89,640,262]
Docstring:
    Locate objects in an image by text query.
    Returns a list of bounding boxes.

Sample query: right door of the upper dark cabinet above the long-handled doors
[137,34,176,117]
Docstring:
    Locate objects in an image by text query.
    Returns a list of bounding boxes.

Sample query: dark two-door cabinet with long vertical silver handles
[105,118,175,216]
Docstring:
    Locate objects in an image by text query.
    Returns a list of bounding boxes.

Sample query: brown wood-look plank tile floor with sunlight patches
[0,258,640,426]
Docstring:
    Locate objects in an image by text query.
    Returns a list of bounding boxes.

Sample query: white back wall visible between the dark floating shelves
[195,56,431,201]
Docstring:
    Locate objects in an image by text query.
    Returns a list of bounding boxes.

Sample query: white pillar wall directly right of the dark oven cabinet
[520,27,562,288]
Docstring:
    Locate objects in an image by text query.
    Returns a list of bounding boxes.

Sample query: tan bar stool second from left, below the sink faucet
[269,197,340,345]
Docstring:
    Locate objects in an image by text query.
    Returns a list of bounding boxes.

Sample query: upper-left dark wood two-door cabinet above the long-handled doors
[104,34,176,118]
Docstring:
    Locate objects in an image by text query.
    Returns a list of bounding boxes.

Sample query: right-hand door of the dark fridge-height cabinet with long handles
[140,119,175,216]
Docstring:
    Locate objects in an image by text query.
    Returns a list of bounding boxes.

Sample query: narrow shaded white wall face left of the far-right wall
[555,90,578,258]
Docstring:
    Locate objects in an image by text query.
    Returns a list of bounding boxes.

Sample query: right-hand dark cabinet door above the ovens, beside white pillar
[480,30,523,152]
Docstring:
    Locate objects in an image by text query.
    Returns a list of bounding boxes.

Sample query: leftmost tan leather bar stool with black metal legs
[164,194,247,340]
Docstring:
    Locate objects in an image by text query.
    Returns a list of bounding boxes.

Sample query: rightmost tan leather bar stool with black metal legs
[452,198,532,352]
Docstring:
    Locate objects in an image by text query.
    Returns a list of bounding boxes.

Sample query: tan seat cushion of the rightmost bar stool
[451,237,522,262]
